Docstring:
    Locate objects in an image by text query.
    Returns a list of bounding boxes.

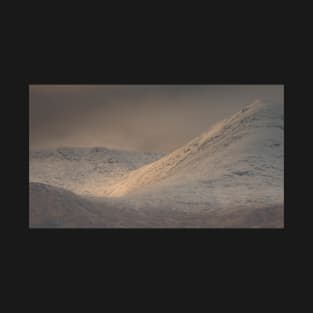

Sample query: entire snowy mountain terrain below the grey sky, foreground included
[30,101,284,227]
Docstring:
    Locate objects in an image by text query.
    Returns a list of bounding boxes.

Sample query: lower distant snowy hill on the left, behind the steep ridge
[29,147,164,196]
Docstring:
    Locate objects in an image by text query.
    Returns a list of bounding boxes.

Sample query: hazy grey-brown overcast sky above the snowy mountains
[30,85,283,152]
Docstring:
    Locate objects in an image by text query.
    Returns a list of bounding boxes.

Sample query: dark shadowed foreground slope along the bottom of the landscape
[29,183,283,228]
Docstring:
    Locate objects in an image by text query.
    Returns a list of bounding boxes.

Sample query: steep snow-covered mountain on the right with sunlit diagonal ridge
[106,101,284,210]
